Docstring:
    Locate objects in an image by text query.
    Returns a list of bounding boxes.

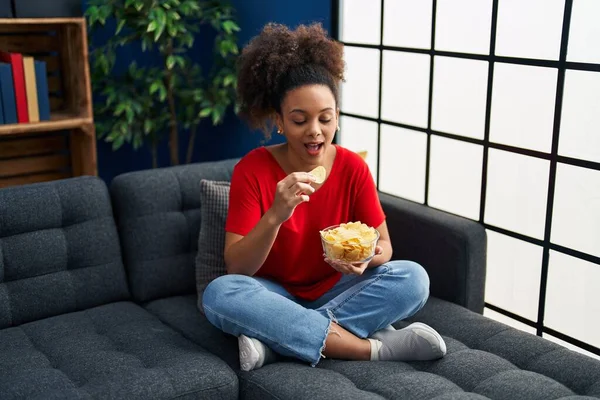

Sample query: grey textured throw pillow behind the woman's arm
[196,179,229,313]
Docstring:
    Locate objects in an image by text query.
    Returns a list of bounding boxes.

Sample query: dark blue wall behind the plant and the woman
[82,0,331,183]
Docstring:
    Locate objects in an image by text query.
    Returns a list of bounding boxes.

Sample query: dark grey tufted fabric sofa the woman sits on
[0,160,600,400]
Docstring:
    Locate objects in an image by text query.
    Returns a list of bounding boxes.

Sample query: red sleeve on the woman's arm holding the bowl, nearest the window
[353,159,385,228]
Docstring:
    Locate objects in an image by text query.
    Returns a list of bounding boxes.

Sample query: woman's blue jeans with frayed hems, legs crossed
[202,261,429,366]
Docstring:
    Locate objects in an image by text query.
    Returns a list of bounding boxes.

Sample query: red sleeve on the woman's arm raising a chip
[225,161,261,236]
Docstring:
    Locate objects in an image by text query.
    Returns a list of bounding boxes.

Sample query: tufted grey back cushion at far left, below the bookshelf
[0,177,129,328]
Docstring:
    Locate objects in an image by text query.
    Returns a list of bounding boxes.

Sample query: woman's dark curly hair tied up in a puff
[237,23,345,138]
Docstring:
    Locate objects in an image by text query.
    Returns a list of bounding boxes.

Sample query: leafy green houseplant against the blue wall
[86,0,239,167]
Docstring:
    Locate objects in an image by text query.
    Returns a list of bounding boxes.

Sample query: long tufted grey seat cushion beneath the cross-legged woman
[146,296,600,400]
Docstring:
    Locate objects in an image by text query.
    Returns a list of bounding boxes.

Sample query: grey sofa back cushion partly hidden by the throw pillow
[111,160,237,302]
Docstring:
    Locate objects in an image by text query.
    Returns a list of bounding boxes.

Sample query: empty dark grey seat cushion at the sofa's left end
[0,302,238,400]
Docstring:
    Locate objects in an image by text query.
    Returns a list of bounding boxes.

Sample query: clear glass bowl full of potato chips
[320,221,379,263]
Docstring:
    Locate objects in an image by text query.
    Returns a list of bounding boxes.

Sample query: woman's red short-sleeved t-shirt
[225,145,385,301]
